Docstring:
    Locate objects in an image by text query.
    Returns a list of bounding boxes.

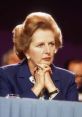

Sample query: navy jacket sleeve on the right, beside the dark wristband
[53,74,78,101]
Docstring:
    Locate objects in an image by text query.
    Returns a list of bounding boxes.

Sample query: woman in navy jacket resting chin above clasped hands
[0,12,77,101]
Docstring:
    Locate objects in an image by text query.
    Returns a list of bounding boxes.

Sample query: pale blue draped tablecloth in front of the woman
[0,98,82,117]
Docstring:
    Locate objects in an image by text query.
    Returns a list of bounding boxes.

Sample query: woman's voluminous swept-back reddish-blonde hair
[13,12,62,59]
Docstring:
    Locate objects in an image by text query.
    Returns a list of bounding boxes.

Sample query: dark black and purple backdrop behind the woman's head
[0,0,82,67]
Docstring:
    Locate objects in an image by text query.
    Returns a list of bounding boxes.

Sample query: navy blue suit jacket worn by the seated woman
[0,60,78,101]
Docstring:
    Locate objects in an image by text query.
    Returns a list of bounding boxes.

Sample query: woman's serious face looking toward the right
[26,29,56,65]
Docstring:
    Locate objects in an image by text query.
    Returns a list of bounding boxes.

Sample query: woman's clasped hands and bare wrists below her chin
[32,64,57,96]
